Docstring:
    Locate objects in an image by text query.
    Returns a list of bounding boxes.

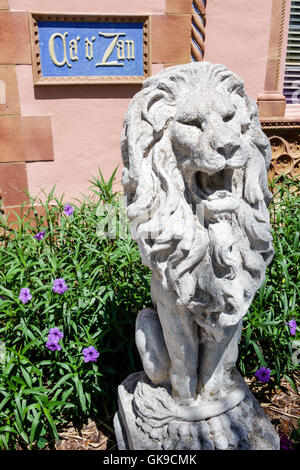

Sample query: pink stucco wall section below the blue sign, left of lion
[17,65,161,199]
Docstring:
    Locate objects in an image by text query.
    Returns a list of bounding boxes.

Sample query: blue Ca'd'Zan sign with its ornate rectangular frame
[31,14,150,84]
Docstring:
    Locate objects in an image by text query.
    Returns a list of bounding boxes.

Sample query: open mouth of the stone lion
[195,168,234,199]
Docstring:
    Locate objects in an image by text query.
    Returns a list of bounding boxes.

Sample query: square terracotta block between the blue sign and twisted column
[152,15,191,64]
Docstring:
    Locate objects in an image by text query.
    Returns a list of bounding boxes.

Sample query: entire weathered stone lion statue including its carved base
[115,62,279,449]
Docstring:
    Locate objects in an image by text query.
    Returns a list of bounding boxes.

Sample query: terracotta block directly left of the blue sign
[0,11,31,64]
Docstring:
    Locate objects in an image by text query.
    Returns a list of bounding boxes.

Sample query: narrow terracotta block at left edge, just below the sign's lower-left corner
[0,65,20,114]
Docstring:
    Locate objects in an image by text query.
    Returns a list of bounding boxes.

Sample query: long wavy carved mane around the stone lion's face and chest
[121,62,273,326]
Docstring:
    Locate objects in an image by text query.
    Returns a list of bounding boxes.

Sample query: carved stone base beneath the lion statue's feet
[114,370,280,450]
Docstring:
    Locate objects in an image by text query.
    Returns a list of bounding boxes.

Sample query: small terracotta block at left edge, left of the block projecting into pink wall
[0,116,26,163]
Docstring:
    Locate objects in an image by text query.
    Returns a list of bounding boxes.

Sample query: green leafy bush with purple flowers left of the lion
[0,173,151,449]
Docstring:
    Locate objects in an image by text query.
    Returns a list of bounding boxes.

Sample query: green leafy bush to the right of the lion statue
[238,179,300,388]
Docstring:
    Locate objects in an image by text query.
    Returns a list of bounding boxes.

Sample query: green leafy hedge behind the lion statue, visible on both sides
[0,173,300,449]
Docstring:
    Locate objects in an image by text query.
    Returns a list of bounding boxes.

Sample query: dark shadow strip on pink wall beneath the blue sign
[34,83,142,100]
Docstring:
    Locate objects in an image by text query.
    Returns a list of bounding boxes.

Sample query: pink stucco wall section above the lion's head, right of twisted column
[205,0,272,100]
